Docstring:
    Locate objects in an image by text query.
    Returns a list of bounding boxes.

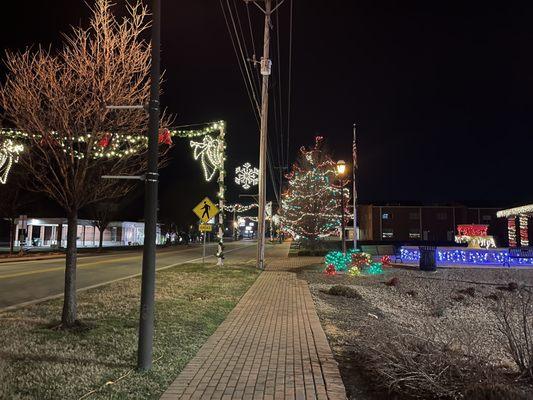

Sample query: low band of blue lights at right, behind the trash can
[400,247,533,266]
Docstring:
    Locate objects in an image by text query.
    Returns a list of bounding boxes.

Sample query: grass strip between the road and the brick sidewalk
[0,264,258,400]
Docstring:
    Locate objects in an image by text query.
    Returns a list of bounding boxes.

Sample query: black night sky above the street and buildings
[0,0,533,225]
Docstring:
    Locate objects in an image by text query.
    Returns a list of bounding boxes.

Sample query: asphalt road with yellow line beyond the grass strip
[0,241,288,310]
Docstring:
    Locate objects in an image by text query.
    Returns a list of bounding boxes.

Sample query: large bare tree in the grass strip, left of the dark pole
[0,0,167,327]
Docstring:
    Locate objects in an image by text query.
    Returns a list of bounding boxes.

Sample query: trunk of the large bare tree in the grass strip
[61,211,78,327]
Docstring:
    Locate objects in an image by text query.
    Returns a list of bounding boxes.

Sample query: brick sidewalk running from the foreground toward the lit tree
[161,258,346,400]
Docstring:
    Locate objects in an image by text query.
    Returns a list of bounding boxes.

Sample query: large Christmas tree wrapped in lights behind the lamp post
[282,136,349,240]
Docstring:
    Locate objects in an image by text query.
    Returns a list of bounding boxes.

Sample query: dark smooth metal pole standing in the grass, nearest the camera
[137,0,161,371]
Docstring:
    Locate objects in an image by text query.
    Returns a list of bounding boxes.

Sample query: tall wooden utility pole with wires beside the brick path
[255,0,272,269]
